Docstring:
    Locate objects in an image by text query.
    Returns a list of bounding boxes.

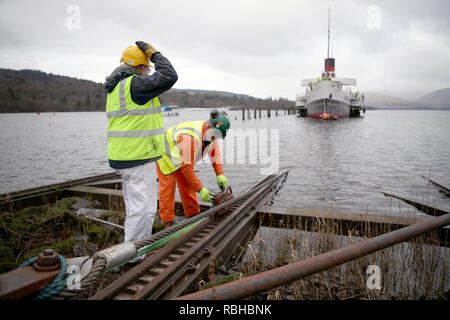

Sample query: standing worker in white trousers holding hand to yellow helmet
[106,41,178,262]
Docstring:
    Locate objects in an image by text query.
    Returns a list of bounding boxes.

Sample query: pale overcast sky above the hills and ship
[0,0,450,100]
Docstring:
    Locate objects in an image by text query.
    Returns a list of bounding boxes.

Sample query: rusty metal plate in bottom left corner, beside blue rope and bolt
[0,266,60,300]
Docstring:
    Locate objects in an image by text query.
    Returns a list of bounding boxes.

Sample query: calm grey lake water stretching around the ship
[0,110,450,215]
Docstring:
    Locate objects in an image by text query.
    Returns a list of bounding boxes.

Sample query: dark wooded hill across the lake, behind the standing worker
[0,68,295,113]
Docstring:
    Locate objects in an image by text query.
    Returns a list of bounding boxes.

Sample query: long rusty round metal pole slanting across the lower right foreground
[178,213,450,300]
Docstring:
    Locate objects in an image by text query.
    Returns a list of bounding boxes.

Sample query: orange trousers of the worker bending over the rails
[156,165,200,223]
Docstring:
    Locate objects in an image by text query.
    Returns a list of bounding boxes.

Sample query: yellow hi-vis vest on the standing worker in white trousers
[106,75,164,161]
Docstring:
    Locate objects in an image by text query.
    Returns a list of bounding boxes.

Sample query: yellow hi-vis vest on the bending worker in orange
[158,121,214,175]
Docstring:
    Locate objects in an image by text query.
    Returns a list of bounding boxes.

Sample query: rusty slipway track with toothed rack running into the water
[90,171,287,300]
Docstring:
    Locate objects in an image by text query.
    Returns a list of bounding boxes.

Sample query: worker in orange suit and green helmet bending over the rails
[157,110,230,228]
